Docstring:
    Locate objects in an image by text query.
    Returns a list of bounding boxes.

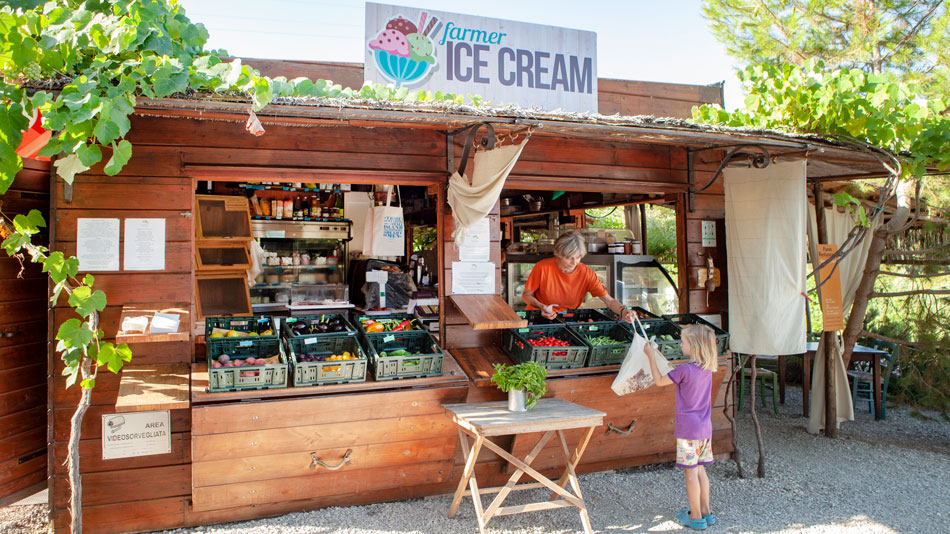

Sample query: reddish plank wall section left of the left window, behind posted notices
[49,145,194,532]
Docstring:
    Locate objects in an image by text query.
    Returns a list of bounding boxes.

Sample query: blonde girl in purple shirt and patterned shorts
[646,325,718,530]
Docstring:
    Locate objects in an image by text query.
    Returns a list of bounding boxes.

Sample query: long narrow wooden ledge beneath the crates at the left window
[191,351,468,404]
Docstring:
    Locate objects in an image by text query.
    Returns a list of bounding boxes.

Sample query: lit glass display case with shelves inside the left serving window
[250,220,351,312]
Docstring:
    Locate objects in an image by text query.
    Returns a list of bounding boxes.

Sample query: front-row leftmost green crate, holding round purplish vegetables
[208,338,287,393]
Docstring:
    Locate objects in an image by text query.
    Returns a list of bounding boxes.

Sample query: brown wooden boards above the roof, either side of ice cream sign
[243,58,723,119]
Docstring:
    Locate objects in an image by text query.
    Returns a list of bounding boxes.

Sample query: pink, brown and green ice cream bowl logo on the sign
[367,11,442,87]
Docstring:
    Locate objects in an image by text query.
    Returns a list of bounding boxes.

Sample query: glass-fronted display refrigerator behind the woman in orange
[504,254,679,315]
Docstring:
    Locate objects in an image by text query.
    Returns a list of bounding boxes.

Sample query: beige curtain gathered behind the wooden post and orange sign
[808,205,874,434]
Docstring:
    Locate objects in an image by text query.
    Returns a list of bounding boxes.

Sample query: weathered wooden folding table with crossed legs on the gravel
[443,399,606,534]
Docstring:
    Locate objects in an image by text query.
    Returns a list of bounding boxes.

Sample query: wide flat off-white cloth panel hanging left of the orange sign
[723,160,807,354]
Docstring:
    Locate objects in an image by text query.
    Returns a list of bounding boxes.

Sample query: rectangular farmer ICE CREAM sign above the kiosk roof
[364,2,597,112]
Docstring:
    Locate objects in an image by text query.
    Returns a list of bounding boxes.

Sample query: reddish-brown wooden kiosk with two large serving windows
[0,62,892,533]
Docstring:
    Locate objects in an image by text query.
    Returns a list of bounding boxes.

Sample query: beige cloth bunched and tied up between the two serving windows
[448,138,528,246]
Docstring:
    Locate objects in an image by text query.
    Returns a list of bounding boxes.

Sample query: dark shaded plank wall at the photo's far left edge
[0,160,49,501]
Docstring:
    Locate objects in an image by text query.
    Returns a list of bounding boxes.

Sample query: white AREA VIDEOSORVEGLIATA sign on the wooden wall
[102,410,172,460]
